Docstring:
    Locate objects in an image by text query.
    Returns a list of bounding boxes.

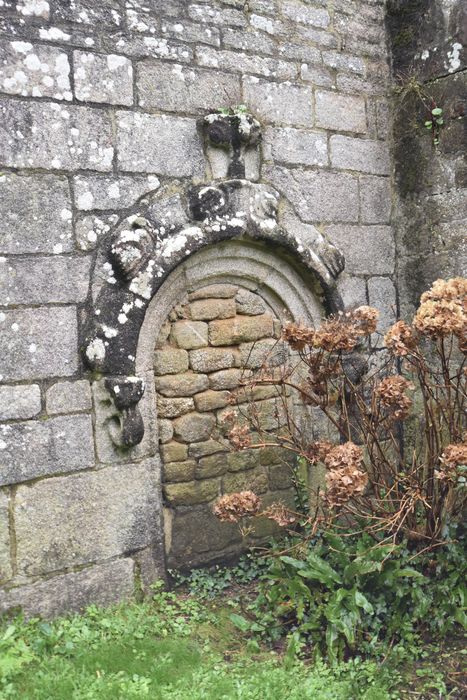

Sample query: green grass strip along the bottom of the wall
[0,589,464,700]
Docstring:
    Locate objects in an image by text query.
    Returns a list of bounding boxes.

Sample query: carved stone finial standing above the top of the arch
[201,112,261,180]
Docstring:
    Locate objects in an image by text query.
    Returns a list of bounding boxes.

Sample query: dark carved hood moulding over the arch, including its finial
[82,114,344,447]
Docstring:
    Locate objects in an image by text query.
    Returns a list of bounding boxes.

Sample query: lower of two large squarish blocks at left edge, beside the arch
[0,307,78,380]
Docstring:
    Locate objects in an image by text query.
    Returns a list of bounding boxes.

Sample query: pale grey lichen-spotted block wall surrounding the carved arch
[0,0,402,614]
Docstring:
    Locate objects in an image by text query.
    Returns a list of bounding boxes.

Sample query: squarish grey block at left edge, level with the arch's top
[0,174,73,254]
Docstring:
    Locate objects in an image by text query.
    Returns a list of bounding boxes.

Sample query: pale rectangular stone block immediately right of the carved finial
[264,128,328,165]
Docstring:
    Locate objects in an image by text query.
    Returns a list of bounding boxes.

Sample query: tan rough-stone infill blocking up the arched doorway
[154,284,293,568]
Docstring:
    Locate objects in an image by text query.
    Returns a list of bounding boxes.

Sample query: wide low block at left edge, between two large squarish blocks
[0,254,91,306]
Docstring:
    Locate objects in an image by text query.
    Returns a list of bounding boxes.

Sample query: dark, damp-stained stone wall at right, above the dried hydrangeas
[388,0,467,316]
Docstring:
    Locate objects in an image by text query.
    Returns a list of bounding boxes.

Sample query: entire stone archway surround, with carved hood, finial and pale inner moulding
[81,110,344,578]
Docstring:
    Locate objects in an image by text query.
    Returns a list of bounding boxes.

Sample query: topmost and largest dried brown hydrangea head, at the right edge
[414,277,467,339]
